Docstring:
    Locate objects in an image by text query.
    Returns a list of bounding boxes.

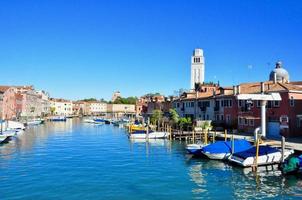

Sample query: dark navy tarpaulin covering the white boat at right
[233,146,280,159]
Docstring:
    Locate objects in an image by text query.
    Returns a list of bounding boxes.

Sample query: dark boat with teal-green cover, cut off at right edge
[280,155,302,175]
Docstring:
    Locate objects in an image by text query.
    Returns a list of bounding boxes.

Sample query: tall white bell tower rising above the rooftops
[191,49,204,90]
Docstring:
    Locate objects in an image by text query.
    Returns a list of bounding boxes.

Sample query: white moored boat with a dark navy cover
[228,146,294,167]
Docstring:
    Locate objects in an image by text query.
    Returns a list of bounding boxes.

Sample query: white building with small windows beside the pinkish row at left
[50,98,73,116]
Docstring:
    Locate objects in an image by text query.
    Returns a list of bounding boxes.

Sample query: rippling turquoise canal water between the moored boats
[0,119,302,200]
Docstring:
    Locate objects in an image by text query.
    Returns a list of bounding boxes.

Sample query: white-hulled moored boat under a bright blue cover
[201,139,252,160]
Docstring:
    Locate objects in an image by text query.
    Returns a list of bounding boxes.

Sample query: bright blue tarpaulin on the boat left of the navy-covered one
[202,140,252,153]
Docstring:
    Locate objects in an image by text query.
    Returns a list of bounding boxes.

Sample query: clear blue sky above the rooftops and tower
[0,0,302,99]
